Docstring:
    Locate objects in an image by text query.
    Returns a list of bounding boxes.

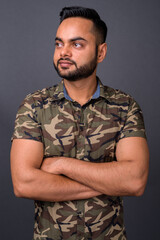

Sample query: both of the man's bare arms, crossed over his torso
[11,137,149,201]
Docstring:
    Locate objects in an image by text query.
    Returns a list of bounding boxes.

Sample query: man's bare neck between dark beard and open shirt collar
[64,75,97,105]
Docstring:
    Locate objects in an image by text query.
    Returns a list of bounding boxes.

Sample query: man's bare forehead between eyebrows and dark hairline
[56,17,95,41]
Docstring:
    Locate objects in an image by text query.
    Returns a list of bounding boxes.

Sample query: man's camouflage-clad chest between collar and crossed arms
[39,102,123,162]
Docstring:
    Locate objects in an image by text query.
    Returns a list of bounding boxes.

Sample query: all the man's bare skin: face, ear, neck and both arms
[11,18,149,201]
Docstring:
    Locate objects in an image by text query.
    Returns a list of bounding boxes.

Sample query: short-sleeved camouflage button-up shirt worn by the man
[13,78,145,240]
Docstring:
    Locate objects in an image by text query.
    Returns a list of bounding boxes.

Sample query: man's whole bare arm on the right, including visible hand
[44,137,149,196]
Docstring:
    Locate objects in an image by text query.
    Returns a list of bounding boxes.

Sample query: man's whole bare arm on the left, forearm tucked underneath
[11,139,100,201]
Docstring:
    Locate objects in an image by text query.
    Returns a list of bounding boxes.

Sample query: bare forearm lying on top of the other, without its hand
[56,158,148,196]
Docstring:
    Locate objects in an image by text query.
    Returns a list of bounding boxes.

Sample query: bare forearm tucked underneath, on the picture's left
[15,169,100,202]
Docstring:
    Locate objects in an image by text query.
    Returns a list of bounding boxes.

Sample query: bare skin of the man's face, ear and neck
[53,17,107,105]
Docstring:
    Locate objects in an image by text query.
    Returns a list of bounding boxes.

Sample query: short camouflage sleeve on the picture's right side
[118,98,146,140]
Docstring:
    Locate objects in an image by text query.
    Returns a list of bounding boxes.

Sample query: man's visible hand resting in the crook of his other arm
[41,157,61,175]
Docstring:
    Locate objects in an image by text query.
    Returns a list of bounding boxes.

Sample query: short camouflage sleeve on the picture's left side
[11,95,42,142]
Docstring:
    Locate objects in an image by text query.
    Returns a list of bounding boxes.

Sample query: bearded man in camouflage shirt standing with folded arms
[11,7,148,240]
